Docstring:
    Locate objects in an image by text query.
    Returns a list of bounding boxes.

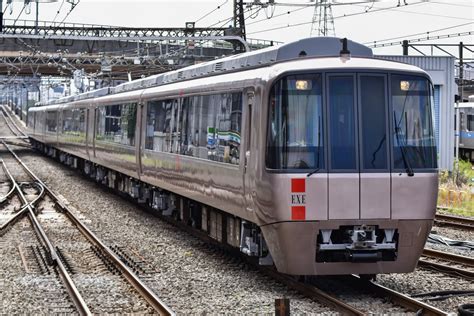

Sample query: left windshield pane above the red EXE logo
[266,75,324,169]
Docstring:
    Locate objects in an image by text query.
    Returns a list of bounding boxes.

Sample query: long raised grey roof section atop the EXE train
[37,37,373,106]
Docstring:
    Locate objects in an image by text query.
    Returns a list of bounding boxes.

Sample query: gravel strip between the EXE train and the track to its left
[15,152,334,314]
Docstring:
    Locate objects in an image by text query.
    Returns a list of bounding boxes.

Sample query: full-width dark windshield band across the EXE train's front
[266,73,437,175]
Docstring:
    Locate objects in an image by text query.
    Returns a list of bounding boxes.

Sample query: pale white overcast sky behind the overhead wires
[3,0,474,57]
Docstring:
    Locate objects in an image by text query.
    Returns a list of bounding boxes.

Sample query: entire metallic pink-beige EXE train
[28,38,438,275]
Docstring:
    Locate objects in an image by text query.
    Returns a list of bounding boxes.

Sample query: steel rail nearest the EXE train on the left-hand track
[2,141,175,315]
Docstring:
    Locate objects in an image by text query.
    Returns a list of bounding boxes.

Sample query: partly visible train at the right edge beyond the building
[459,102,474,162]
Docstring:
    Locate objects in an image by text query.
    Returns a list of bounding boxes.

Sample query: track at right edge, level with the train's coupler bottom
[418,249,474,280]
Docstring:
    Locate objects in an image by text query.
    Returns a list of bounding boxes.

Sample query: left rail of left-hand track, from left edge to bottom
[2,152,92,315]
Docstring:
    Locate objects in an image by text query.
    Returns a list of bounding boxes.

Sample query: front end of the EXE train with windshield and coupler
[262,59,438,275]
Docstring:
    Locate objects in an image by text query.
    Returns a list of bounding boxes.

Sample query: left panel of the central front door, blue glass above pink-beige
[326,73,360,219]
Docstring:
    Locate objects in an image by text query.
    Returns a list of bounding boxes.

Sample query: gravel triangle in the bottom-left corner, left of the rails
[0,217,77,315]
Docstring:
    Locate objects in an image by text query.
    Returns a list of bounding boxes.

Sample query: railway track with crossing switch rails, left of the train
[0,140,174,315]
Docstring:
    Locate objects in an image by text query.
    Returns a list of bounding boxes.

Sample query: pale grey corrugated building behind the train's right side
[375,55,458,170]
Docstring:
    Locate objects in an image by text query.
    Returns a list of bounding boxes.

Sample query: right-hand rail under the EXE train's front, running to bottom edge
[352,275,448,316]
